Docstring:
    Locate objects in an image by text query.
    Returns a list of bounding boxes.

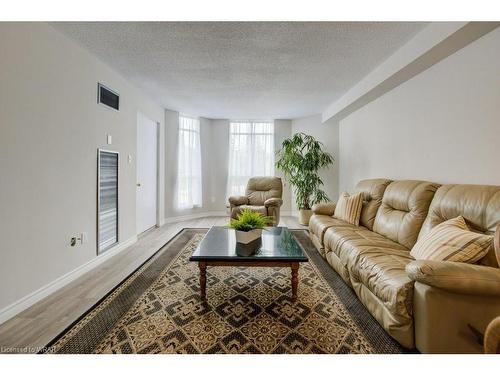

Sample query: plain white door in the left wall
[136,112,158,234]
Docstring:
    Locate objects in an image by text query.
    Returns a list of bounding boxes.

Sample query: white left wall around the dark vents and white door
[0,23,164,310]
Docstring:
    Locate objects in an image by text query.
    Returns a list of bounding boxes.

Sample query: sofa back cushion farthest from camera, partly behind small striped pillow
[355,178,392,230]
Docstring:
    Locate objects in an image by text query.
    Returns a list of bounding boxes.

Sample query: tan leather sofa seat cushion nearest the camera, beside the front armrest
[347,246,414,321]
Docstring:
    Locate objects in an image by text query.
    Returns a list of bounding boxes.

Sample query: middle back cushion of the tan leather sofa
[373,180,439,249]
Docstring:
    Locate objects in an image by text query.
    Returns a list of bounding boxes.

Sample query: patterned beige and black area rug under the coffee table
[47,229,403,353]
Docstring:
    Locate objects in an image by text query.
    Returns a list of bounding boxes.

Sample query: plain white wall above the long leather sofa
[340,29,500,190]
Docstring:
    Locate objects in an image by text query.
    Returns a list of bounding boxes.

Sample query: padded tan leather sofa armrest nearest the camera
[406,260,500,297]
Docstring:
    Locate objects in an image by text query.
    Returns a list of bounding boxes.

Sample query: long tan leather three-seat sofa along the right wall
[309,179,500,353]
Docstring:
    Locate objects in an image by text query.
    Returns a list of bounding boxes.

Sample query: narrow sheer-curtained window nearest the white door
[176,116,202,209]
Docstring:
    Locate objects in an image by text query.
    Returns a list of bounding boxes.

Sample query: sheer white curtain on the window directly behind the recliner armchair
[226,121,274,197]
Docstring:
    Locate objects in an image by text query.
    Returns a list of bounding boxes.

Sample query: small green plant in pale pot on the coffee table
[229,209,273,244]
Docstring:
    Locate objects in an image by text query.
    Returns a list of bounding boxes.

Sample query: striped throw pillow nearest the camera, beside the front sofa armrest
[410,216,493,263]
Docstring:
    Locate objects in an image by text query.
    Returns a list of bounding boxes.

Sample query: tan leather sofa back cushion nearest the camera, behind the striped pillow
[419,185,500,267]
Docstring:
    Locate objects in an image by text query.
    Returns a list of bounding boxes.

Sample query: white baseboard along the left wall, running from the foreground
[0,236,137,324]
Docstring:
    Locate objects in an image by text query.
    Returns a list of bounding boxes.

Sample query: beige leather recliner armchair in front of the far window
[229,177,283,226]
